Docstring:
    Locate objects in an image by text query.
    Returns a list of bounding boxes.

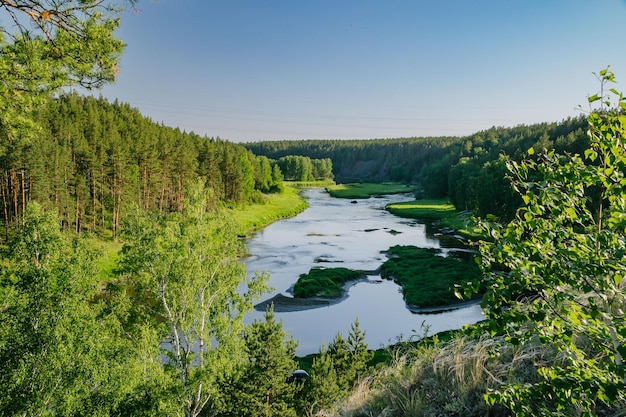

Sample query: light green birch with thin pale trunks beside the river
[120,180,265,416]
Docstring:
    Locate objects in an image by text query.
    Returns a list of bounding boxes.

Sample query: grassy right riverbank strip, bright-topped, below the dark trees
[386,199,483,239]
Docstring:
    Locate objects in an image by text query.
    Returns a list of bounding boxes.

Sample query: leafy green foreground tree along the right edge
[467,70,626,415]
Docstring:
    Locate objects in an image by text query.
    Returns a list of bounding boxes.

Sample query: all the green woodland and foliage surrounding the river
[0,0,626,417]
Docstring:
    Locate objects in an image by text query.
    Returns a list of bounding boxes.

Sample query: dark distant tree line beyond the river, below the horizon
[245,116,589,219]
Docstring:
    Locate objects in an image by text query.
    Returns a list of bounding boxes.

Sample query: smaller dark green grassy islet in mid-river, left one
[293,267,363,298]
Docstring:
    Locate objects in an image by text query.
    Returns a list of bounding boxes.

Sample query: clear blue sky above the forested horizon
[95,0,626,142]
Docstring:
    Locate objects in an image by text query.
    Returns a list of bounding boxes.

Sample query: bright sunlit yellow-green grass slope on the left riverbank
[226,185,308,236]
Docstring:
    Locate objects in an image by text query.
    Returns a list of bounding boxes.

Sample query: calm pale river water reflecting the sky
[246,188,483,355]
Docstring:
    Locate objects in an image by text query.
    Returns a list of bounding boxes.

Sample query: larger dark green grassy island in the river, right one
[381,246,482,307]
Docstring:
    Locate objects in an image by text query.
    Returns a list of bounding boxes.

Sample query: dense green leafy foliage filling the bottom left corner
[0,203,161,416]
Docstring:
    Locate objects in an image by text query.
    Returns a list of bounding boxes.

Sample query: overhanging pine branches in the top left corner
[0,0,129,137]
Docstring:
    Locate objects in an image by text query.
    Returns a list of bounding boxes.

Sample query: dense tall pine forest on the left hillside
[0,94,282,236]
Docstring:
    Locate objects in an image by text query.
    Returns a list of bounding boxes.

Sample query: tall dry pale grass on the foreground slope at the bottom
[329,334,553,417]
